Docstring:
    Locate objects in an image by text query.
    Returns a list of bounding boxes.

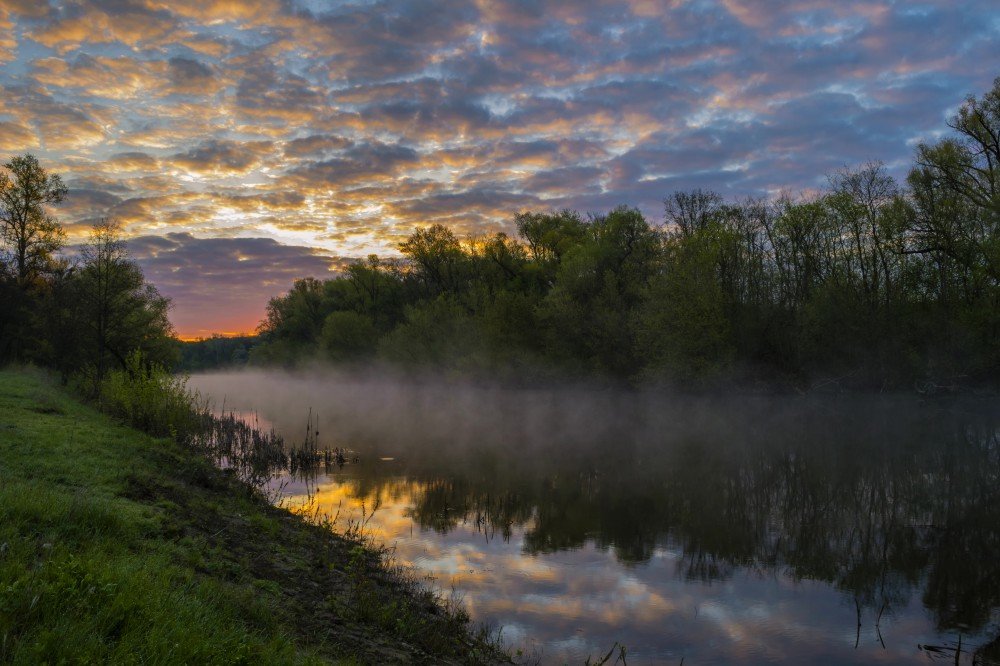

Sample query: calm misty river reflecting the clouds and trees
[192,373,1000,666]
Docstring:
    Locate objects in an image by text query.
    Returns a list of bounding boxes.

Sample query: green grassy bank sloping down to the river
[0,370,501,664]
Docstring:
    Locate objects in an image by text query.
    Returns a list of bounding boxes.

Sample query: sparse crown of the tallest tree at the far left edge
[0,154,66,286]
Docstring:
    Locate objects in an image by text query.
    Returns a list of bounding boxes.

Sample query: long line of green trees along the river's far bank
[250,78,1000,387]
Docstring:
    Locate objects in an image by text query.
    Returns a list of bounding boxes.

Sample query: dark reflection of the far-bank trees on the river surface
[314,399,1000,663]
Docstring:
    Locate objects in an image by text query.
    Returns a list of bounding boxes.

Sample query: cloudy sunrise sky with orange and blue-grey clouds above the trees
[0,0,1000,338]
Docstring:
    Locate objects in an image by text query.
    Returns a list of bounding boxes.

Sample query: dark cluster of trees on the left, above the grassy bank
[0,155,176,394]
